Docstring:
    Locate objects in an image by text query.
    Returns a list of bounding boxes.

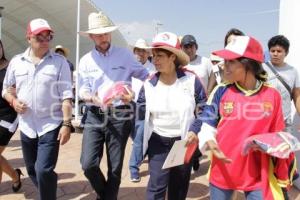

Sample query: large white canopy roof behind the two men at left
[0,0,127,64]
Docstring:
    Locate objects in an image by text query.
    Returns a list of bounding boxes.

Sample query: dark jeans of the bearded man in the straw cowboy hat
[81,107,134,200]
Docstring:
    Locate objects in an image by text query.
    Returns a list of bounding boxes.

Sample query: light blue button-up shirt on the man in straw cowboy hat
[79,46,148,104]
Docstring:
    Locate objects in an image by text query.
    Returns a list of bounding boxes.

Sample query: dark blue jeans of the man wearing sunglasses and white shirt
[21,127,60,200]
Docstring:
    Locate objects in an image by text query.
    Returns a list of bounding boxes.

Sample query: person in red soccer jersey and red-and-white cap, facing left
[190,36,295,200]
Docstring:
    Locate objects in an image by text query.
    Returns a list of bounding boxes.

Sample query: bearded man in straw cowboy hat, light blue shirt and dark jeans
[79,12,148,200]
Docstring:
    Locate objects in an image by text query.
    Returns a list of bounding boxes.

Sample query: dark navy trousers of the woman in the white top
[147,133,191,200]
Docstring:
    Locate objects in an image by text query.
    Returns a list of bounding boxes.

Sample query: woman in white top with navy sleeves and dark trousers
[137,32,206,200]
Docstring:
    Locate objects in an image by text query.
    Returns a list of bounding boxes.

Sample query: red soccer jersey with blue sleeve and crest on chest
[199,83,296,197]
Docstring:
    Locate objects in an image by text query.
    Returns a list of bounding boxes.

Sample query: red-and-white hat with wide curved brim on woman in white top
[151,32,190,66]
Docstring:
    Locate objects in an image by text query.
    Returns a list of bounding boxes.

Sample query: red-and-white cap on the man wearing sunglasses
[26,18,53,36]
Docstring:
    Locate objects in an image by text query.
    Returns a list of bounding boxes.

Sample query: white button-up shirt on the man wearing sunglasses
[2,48,73,138]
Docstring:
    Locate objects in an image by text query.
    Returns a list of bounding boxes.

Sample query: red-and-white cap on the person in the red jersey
[213,36,264,62]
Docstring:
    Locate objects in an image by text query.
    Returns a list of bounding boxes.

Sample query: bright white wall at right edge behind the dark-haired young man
[279,0,300,189]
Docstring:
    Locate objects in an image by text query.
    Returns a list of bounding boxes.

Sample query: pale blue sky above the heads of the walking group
[93,0,280,56]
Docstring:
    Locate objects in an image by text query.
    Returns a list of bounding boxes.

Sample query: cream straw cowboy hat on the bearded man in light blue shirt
[79,12,118,36]
